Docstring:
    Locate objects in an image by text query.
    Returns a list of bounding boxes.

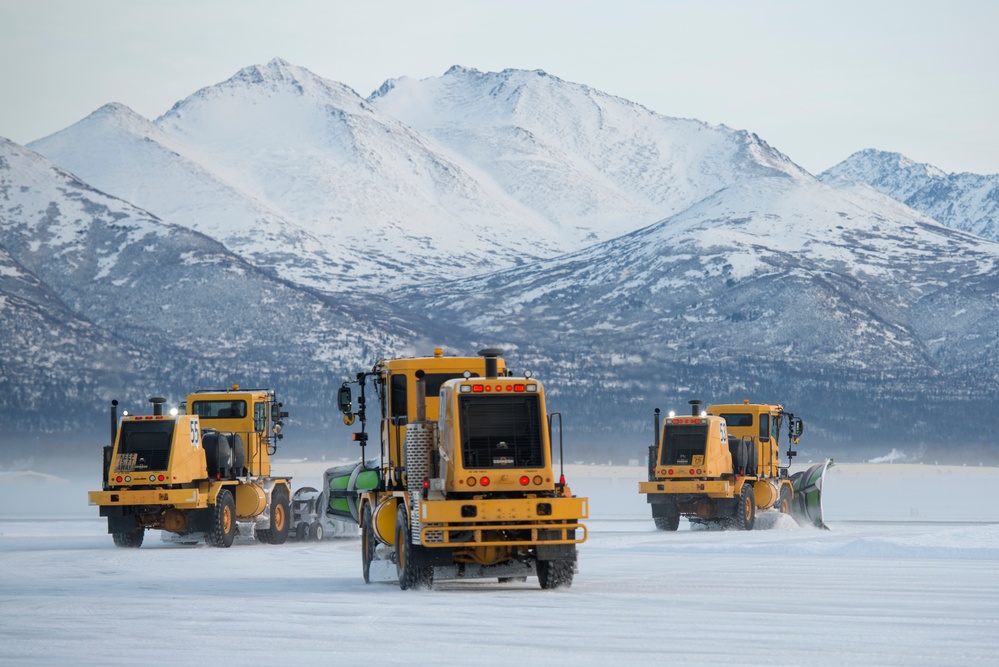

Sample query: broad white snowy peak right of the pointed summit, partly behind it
[368,66,804,248]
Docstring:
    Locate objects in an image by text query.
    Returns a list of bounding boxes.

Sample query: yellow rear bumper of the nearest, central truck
[420,498,589,547]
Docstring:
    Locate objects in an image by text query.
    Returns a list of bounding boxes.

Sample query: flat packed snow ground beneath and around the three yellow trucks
[0,464,999,665]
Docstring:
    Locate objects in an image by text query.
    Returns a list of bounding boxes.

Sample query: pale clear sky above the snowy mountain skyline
[0,0,999,174]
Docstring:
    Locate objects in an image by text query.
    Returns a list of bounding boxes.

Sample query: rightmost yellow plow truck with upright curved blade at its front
[639,400,831,530]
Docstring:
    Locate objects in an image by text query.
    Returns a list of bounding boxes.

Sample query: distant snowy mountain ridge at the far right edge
[820,149,999,241]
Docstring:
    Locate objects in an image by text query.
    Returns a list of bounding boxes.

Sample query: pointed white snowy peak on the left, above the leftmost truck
[30,59,563,293]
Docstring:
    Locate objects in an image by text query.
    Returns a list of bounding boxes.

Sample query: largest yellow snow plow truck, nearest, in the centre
[338,348,588,589]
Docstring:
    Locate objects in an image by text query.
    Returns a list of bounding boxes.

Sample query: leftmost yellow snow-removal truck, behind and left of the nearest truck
[89,385,291,547]
